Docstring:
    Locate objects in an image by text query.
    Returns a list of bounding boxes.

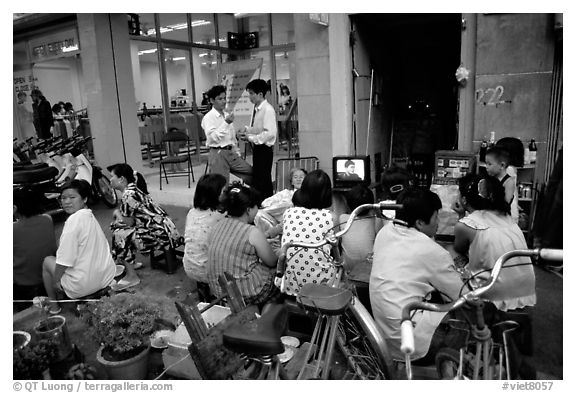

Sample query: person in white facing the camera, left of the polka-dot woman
[254,168,307,237]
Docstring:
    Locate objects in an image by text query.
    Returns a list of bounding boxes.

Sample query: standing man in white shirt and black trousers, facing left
[242,79,278,199]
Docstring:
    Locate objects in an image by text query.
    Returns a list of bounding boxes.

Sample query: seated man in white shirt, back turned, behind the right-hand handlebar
[369,188,466,360]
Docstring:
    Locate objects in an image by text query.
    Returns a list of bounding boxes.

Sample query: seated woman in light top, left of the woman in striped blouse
[182,173,226,301]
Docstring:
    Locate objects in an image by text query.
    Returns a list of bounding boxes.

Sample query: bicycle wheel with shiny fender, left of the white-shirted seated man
[337,297,392,379]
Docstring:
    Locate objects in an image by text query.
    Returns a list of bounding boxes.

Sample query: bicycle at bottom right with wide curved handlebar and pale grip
[400,248,563,380]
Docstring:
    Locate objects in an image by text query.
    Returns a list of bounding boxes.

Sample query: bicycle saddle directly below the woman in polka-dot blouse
[298,284,352,315]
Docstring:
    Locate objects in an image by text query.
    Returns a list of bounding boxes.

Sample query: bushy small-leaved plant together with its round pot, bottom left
[80,293,162,379]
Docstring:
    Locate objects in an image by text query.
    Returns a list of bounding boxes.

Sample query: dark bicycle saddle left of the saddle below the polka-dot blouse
[222,304,288,355]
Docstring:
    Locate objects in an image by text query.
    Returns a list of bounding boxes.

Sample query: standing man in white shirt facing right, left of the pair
[202,85,252,184]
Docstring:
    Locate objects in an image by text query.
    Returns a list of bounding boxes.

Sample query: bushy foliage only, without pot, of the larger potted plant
[80,293,162,361]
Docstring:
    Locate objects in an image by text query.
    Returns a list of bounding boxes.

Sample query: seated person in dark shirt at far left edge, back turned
[12,189,57,311]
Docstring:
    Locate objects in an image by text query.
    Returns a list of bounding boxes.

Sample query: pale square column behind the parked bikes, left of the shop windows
[78,14,142,170]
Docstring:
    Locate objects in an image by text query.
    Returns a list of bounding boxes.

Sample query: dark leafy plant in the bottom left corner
[12,339,58,379]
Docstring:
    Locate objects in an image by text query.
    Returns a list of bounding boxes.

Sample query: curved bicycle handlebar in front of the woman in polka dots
[276,202,405,277]
